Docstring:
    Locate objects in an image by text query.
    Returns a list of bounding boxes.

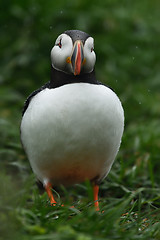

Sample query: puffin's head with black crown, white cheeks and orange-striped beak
[51,30,96,75]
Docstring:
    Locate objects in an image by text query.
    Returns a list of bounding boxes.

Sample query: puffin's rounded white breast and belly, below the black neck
[21,83,124,185]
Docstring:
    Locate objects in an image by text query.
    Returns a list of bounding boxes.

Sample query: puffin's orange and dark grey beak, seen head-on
[71,40,84,75]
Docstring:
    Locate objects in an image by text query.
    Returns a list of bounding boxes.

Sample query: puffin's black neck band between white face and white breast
[50,66,99,88]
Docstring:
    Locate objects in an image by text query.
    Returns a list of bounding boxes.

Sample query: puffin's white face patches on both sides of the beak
[51,33,96,73]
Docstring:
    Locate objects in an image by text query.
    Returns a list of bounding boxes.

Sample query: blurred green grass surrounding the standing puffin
[0,0,160,240]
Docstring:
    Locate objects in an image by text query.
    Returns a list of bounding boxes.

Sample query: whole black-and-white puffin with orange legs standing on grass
[20,30,124,211]
